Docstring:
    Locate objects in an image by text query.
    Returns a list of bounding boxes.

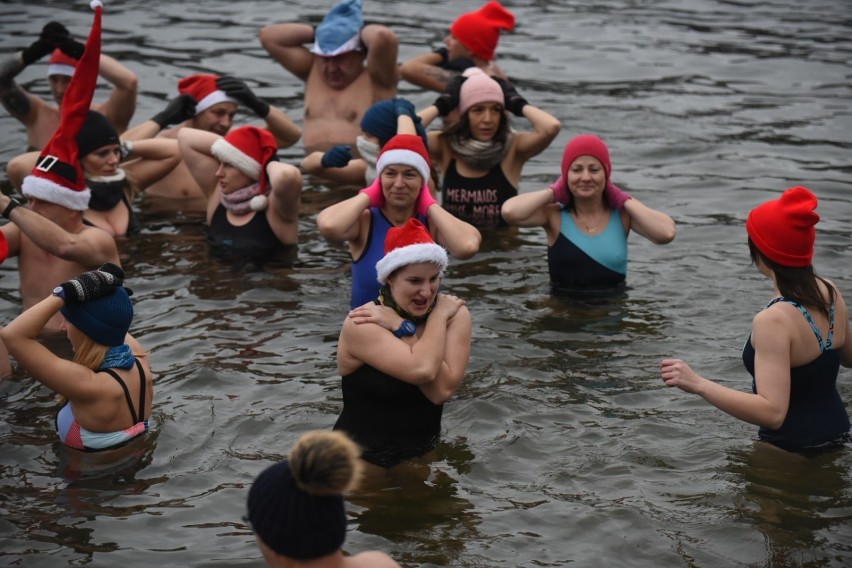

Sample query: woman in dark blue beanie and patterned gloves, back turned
[0,264,154,451]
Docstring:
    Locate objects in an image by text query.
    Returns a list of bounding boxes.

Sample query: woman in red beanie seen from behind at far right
[660,187,852,451]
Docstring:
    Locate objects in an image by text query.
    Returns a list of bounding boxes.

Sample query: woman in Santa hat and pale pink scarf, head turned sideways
[178,126,302,260]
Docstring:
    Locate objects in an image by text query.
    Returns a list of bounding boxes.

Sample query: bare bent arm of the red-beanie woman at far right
[660,310,791,429]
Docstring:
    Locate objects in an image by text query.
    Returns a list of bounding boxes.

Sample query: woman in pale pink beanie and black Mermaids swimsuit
[419,68,560,228]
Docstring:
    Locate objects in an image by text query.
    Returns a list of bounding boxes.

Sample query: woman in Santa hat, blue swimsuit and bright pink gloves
[317,133,482,308]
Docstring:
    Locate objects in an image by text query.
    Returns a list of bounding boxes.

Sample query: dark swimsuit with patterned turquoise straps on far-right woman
[743,296,850,450]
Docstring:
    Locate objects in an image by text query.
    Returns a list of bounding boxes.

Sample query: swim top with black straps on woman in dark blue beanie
[56,359,148,452]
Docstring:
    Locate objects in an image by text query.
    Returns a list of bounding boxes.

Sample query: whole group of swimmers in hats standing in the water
[0,0,852,566]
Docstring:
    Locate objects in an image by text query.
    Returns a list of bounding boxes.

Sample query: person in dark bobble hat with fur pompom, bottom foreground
[244,431,399,568]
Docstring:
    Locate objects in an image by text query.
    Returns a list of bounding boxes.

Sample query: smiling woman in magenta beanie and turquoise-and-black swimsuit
[502,134,675,294]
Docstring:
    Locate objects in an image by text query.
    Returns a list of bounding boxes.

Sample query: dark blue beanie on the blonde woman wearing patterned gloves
[59,288,133,347]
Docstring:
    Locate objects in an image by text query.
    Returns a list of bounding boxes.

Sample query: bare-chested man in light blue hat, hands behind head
[260,0,399,153]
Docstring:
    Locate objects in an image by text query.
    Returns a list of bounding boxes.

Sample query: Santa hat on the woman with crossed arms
[376,218,449,285]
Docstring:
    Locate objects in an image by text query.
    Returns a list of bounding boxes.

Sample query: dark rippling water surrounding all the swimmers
[0,0,852,567]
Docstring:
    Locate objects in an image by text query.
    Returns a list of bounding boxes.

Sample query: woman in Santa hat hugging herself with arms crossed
[334,219,471,468]
